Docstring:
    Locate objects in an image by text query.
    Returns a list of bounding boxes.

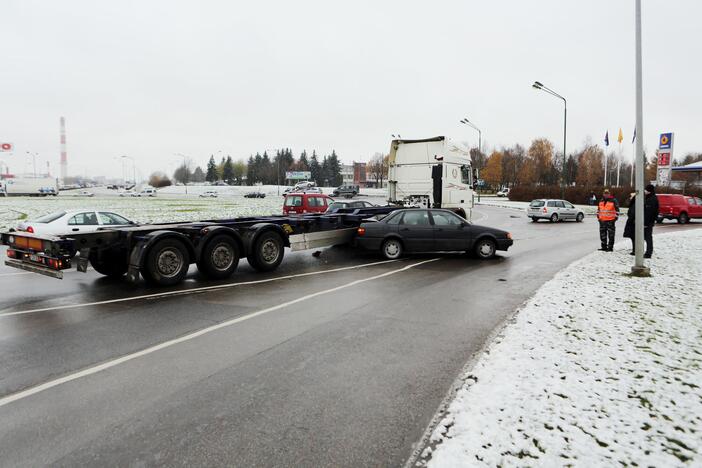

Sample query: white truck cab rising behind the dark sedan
[388,136,474,219]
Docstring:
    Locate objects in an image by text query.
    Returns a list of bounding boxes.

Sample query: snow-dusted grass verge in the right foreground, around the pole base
[420,230,702,467]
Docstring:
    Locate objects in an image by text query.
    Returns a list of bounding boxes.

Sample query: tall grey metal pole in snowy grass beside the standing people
[631,0,651,276]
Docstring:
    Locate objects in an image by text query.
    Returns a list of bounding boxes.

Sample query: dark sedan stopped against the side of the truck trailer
[356,209,513,259]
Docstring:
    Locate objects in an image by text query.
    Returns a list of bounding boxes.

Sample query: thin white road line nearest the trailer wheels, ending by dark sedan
[0,260,398,318]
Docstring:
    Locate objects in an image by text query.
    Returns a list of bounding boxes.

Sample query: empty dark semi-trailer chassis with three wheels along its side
[0,206,398,286]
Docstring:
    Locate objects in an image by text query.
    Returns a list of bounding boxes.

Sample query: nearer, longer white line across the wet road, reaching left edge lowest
[0,258,439,407]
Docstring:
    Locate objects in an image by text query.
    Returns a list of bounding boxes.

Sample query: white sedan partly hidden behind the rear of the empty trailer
[17,210,134,234]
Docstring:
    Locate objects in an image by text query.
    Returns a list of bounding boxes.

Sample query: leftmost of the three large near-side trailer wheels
[142,239,190,286]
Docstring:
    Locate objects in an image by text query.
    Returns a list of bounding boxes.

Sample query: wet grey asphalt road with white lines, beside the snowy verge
[0,207,696,466]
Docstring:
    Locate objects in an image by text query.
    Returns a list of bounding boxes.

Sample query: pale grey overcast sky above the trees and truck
[0,0,702,177]
